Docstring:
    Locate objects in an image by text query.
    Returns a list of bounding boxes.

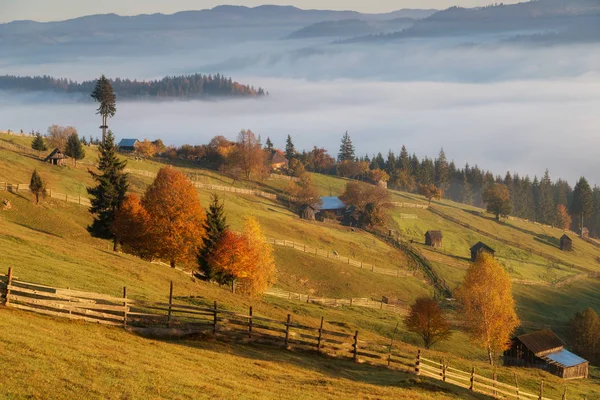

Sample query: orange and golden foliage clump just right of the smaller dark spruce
[209,217,275,295]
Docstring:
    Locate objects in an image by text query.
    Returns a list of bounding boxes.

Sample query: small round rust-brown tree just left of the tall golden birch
[404,297,452,349]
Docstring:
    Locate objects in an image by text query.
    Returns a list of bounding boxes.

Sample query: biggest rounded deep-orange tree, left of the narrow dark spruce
[142,166,205,268]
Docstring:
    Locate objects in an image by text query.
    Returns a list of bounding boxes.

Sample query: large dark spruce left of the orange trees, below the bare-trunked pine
[87,131,129,250]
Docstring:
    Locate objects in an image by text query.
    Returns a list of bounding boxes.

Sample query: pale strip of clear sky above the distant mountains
[0,0,518,22]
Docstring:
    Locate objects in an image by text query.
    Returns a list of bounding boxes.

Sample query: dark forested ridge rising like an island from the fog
[0,74,267,99]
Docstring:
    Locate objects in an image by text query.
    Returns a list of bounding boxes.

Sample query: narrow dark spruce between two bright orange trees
[198,194,228,281]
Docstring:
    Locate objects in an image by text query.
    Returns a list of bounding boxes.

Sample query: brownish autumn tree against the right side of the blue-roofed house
[340,182,390,227]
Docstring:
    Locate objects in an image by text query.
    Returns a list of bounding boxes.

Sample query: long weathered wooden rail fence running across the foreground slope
[0,268,567,400]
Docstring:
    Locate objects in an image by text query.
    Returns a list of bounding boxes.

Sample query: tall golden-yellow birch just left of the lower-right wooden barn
[454,253,519,365]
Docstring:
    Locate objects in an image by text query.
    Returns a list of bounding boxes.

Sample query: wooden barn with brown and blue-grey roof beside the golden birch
[504,329,589,379]
